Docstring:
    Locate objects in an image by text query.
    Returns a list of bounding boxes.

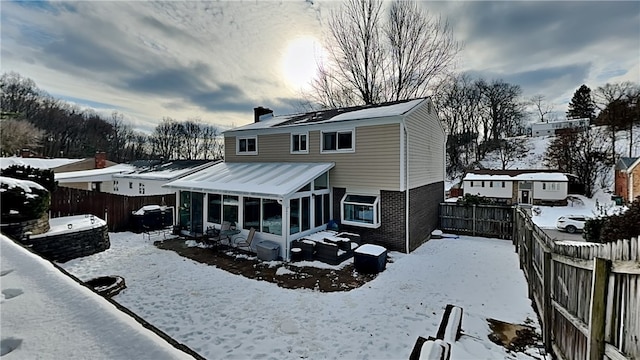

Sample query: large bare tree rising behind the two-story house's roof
[310,0,461,107]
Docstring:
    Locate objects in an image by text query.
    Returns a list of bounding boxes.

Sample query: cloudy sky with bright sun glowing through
[0,0,640,132]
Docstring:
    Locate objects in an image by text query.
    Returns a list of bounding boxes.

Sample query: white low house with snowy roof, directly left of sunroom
[116,160,220,196]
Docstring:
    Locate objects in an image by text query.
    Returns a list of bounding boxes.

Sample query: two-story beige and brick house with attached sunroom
[166,98,445,259]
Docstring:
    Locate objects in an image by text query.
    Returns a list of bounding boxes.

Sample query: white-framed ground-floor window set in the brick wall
[340,194,380,228]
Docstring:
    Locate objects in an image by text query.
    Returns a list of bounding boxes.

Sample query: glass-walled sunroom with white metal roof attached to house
[164,162,334,259]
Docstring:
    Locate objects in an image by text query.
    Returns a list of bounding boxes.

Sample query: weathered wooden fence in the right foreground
[513,209,640,360]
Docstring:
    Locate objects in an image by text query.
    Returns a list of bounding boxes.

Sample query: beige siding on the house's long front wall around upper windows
[225,124,400,191]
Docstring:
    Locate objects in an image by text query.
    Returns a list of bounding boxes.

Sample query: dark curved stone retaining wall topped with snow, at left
[18,225,111,262]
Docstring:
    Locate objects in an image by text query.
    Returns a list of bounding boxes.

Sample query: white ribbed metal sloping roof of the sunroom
[164,162,335,198]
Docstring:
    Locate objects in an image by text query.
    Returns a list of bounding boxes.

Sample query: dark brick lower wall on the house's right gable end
[409,182,444,251]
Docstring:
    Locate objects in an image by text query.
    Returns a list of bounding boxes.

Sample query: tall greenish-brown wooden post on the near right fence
[587,258,610,360]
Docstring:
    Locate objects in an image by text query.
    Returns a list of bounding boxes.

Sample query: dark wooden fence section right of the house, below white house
[440,203,514,239]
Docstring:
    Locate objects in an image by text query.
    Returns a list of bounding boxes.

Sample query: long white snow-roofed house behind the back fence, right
[462,170,569,205]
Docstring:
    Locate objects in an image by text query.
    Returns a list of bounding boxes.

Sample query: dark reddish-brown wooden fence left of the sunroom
[50,187,176,231]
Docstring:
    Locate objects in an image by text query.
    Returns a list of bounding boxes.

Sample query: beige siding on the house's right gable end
[405,100,445,188]
